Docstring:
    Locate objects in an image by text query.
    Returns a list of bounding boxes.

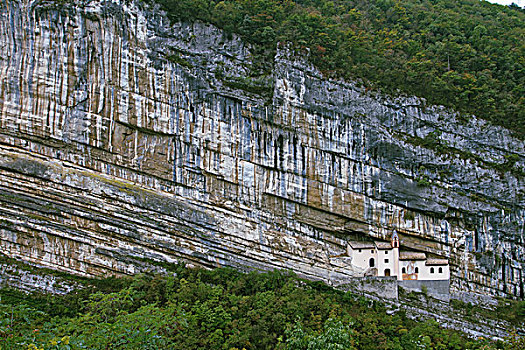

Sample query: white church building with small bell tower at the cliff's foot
[347,231,450,281]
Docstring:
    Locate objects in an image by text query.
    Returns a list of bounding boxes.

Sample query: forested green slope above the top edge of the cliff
[150,0,525,137]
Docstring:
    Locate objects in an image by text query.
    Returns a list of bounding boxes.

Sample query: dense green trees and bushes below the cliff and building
[0,266,524,350]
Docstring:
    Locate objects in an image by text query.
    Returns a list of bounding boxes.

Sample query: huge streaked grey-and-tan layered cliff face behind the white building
[0,0,525,298]
